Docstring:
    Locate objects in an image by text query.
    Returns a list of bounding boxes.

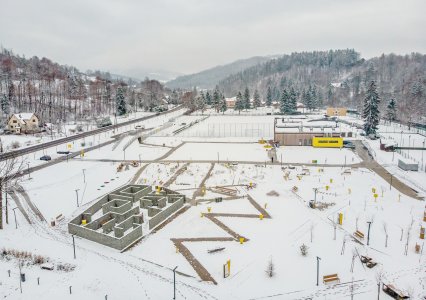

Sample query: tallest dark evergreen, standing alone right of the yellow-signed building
[362,81,380,135]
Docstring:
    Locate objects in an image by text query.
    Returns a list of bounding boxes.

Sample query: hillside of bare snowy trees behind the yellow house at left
[0,48,178,123]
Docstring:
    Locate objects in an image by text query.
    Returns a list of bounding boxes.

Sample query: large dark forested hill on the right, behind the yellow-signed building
[218,49,426,120]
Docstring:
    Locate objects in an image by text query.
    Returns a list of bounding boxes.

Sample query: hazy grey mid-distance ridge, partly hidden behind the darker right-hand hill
[166,56,273,89]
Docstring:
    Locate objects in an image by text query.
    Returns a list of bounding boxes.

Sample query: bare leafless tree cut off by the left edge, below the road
[0,157,25,229]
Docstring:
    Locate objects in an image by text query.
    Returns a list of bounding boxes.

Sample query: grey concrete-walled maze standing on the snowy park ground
[68,185,186,250]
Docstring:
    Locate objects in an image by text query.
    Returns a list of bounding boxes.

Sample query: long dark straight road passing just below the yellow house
[0,105,182,161]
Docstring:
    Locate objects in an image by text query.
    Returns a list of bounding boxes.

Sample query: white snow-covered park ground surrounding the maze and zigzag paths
[0,113,426,300]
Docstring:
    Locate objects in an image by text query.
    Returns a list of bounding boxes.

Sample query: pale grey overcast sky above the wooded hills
[0,0,426,75]
